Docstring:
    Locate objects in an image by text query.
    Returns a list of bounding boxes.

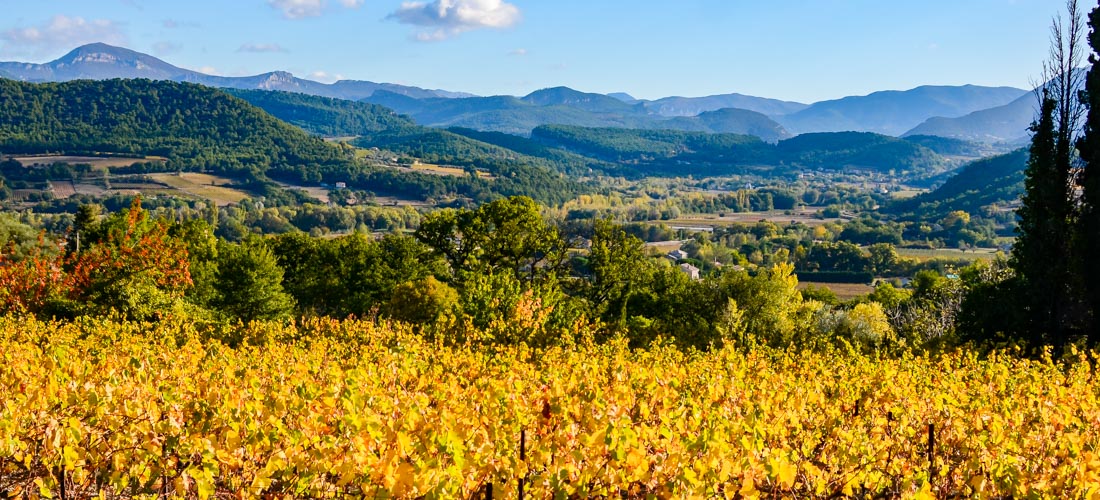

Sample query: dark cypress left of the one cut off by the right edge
[1012,90,1071,345]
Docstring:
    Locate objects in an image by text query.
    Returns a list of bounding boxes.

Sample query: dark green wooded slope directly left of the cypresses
[888,148,1027,219]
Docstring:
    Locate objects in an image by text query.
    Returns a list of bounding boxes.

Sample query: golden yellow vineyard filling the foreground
[0,318,1100,498]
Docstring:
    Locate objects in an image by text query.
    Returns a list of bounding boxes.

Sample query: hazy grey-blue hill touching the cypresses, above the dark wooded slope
[905,92,1038,143]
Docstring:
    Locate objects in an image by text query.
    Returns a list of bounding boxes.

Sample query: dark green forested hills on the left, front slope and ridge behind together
[0,80,580,203]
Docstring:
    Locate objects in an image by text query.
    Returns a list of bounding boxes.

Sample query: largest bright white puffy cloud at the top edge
[386,0,520,42]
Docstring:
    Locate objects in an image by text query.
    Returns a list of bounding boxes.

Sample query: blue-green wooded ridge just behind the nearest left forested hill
[227,89,414,136]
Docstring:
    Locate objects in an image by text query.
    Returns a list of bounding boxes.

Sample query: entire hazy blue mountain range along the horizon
[0,43,1034,143]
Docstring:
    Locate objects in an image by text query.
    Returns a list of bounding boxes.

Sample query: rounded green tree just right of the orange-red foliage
[215,240,294,322]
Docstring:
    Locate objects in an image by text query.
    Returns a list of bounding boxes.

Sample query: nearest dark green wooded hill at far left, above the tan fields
[0,79,347,174]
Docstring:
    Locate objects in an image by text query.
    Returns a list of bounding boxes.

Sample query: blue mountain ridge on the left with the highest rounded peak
[0,43,469,100]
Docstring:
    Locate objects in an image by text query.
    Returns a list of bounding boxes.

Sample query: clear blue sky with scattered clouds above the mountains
[0,0,1069,103]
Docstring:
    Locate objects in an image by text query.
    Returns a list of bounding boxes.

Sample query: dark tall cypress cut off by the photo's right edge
[1076,2,1100,342]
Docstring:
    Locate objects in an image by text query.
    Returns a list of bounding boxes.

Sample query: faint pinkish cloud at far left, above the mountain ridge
[0,15,127,55]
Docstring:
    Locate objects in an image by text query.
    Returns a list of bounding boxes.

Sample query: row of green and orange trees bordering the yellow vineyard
[0,198,1012,349]
